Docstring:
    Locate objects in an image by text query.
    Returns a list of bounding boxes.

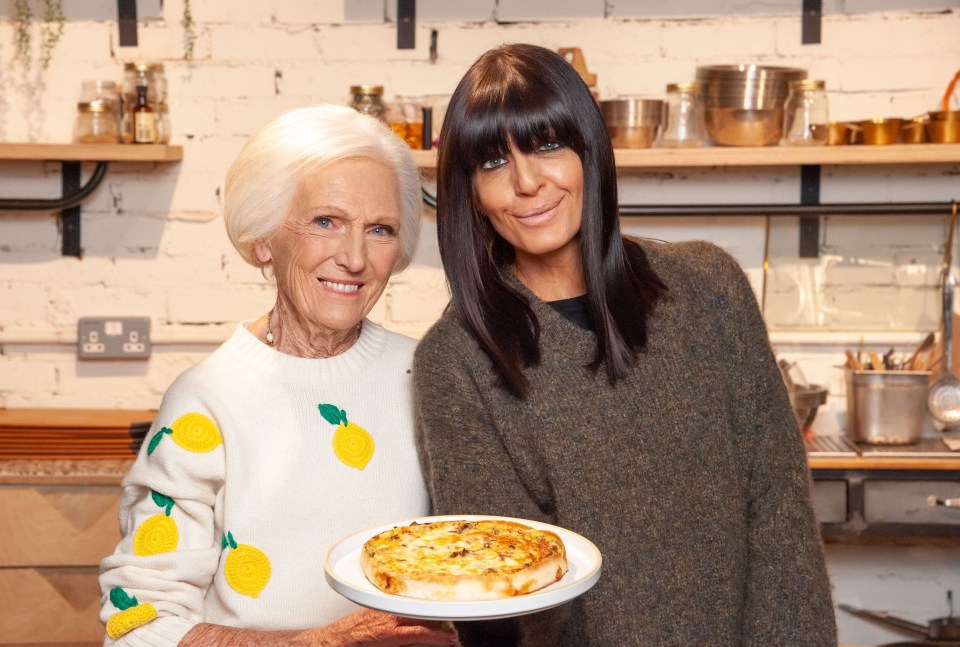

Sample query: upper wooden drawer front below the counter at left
[0,485,120,568]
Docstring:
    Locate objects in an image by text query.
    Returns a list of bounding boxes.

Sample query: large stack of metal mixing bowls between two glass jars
[697,65,807,146]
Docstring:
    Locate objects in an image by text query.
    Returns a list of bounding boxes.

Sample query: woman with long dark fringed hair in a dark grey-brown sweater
[414,45,836,647]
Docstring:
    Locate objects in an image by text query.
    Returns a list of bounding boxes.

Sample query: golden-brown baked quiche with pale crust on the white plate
[360,519,567,602]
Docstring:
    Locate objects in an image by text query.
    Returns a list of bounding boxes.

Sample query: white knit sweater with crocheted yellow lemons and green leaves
[100,321,429,647]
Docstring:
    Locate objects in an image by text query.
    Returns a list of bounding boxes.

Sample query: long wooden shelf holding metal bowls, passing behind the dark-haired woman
[413,144,960,169]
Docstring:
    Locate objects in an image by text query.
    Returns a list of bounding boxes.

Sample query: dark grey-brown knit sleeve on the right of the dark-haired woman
[701,250,837,647]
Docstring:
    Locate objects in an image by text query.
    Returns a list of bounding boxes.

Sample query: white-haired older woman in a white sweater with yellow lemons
[100,106,454,647]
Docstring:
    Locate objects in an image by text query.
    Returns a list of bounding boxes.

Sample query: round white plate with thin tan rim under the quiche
[323,515,602,620]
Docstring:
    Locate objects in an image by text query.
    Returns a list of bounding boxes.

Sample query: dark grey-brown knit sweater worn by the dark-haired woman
[414,241,836,647]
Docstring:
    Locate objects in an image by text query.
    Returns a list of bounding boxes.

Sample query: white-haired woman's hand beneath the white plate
[321,609,457,647]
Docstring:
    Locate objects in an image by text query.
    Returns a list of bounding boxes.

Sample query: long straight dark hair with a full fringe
[437,44,666,398]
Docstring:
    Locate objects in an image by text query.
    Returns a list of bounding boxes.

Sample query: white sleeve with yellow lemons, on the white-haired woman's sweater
[100,380,225,647]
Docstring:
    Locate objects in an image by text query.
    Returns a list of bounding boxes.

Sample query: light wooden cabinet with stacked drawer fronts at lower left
[0,474,126,647]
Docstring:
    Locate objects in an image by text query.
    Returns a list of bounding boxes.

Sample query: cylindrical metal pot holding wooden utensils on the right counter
[844,369,931,445]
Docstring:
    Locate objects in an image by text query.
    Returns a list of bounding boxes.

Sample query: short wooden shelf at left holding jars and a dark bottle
[0,144,183,162]
